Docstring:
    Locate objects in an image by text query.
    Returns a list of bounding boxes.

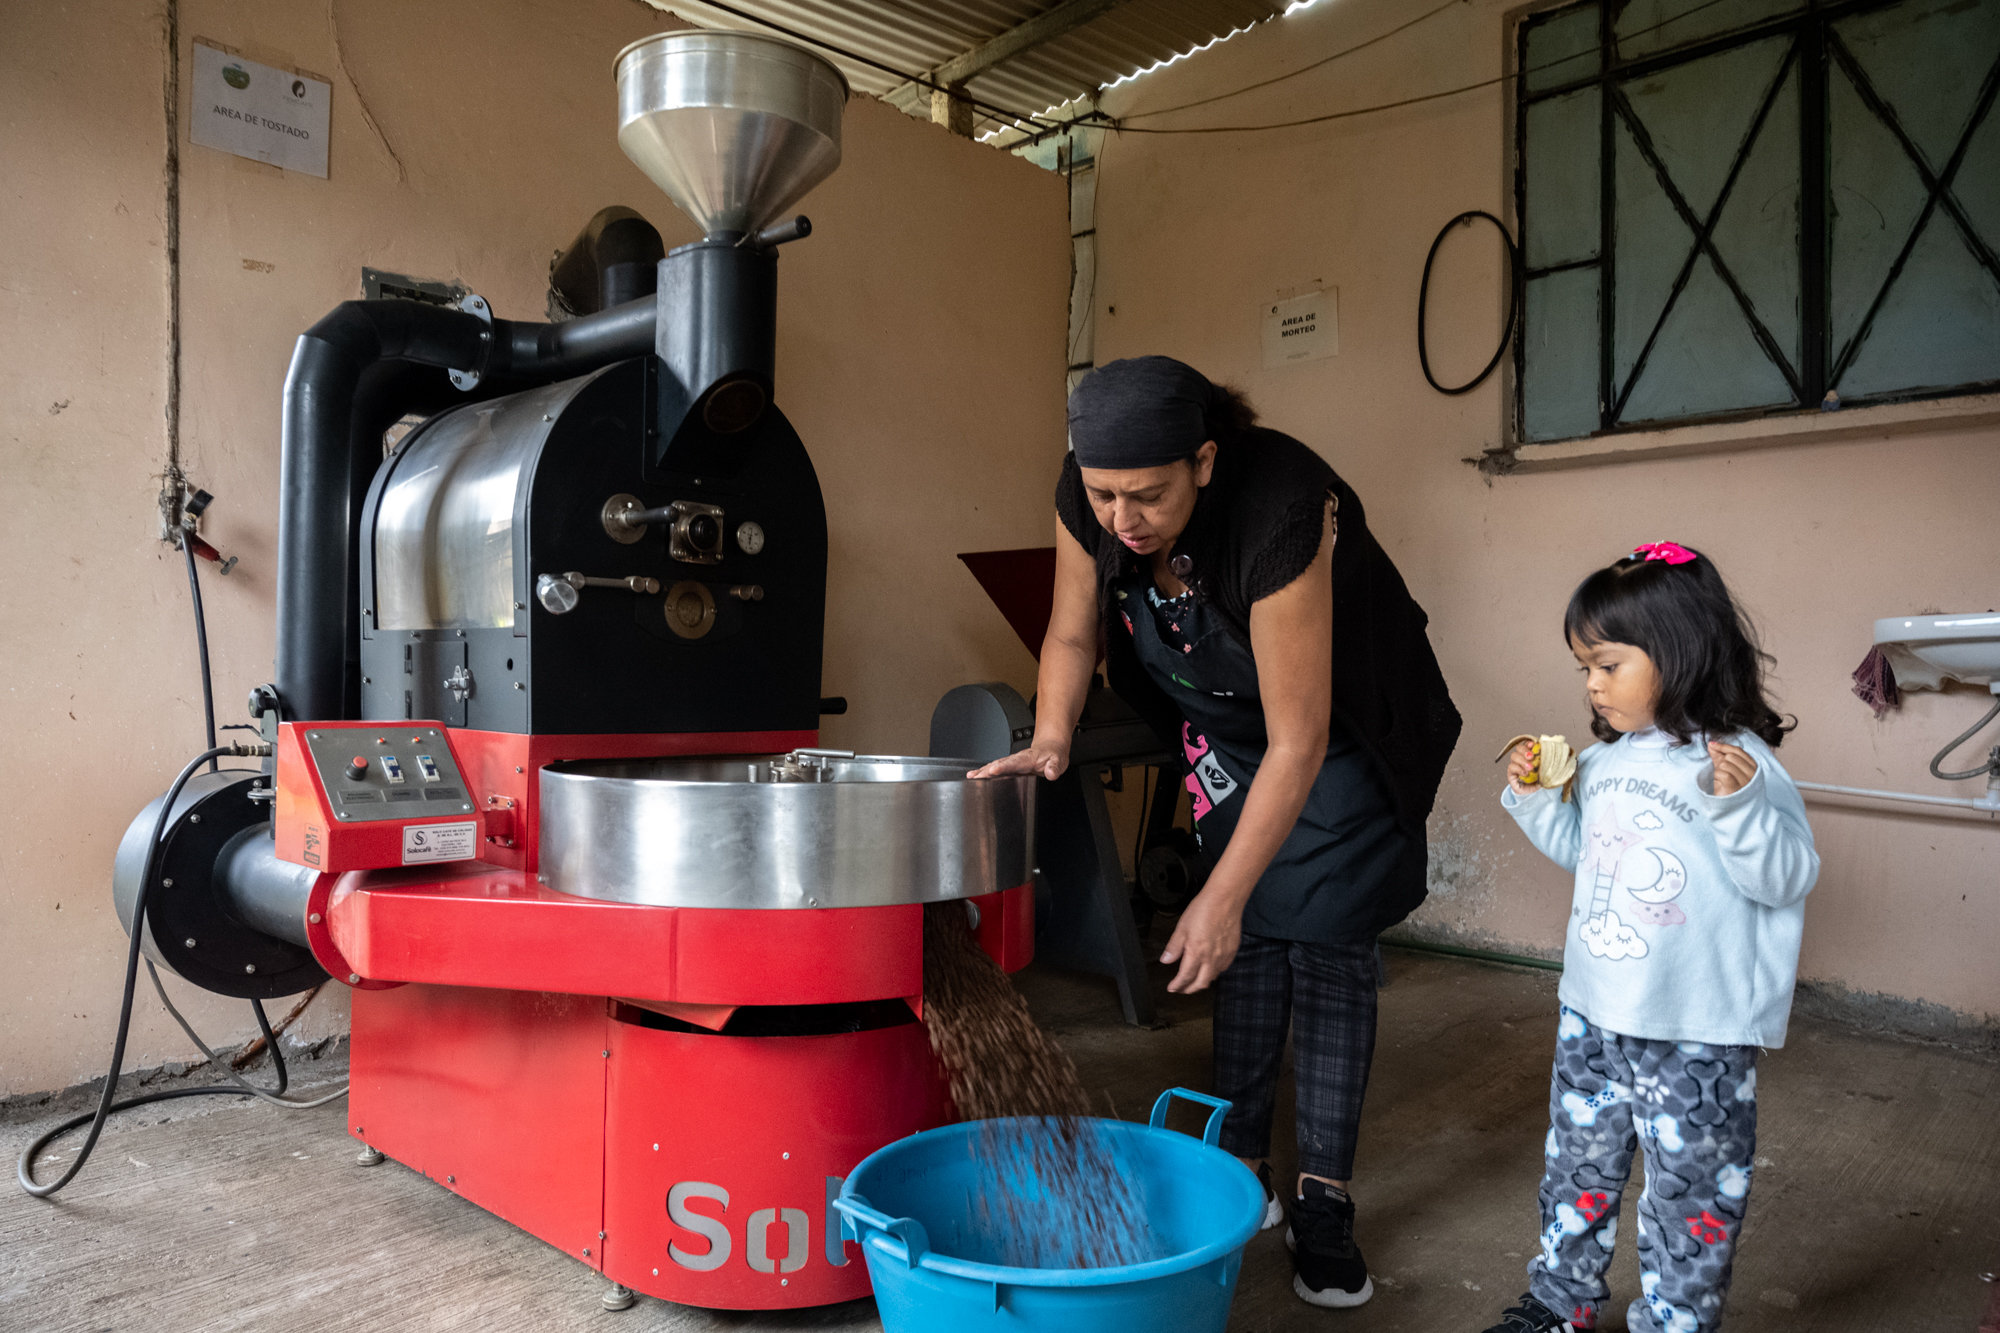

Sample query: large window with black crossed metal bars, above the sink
[1514,0,2000,442]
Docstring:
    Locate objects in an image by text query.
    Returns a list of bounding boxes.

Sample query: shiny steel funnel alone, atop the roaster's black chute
[618,32,848,236]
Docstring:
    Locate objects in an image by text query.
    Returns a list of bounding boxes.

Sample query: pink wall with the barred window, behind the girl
[1096,0,2000,1021]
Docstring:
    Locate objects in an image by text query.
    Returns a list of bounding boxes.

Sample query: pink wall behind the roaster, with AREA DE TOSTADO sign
[0,0,1068,1095]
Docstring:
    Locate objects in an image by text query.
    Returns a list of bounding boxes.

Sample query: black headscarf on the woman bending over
[1070,356,1218,468]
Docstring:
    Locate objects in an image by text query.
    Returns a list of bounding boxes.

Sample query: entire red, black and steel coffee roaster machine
[116,32,1034,1309]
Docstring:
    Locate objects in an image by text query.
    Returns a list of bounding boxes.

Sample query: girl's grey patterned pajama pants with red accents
[1528,1007,1758,1333]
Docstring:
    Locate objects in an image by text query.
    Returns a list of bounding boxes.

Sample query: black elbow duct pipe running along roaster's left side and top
[266,298,656,721]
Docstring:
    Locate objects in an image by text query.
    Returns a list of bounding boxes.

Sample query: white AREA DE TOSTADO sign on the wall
[188,42,334,180]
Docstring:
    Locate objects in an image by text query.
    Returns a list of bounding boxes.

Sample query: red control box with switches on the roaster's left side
[276,723,484,873]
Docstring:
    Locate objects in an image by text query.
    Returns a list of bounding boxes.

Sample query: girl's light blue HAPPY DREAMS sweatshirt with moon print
[1500,729,1820,1047]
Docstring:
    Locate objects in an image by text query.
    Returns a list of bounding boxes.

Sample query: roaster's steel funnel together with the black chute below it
[616,32,848,440]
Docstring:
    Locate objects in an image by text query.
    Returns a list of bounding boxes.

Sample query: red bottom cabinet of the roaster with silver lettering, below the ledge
[348,985,950,1309]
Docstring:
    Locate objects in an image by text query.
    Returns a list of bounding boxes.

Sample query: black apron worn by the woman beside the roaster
[1114,570,1424,945]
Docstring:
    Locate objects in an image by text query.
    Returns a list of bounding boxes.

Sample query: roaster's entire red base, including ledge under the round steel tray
[344,875,1034,1309]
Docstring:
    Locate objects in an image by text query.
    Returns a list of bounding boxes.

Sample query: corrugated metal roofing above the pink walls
[648,0,1286,140]
